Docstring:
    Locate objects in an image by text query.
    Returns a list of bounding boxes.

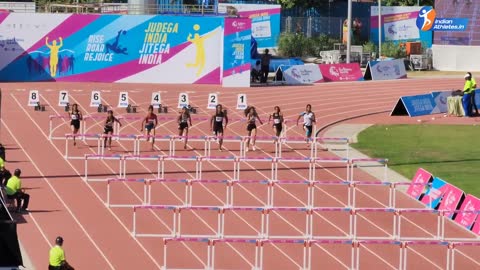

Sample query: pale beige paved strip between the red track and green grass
[324,124,410,191]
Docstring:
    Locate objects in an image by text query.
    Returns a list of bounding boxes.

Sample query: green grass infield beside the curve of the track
[352,125,480,197]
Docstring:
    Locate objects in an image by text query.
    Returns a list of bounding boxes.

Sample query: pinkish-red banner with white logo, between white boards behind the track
[319,63,363,82]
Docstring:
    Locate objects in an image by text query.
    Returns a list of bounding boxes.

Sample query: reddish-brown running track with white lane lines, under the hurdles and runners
[1,79,480,269]
